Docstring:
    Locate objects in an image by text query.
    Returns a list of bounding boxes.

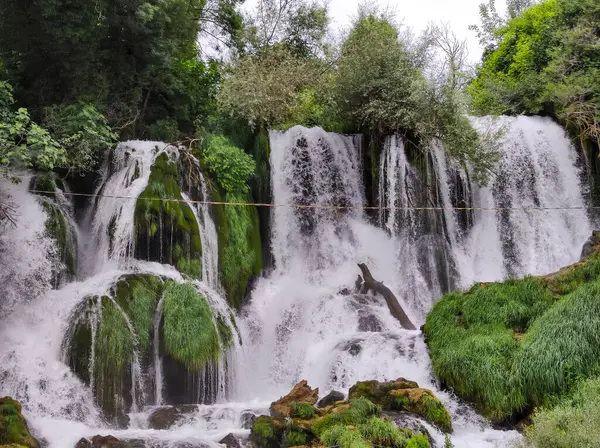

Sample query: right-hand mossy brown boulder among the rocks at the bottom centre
[350,378,452,433]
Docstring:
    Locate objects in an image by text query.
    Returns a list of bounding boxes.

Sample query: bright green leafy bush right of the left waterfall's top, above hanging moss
[202,136,256,194]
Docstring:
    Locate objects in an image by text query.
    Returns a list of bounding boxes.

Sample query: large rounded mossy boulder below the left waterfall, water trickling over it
[63,274,233,427]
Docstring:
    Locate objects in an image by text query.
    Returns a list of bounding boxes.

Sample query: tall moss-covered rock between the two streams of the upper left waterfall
[135,153,202,279]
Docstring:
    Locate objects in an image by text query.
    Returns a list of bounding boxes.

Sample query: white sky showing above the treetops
[329,0,488,62]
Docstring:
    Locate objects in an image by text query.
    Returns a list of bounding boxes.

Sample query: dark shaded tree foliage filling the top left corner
[0,0,234,136]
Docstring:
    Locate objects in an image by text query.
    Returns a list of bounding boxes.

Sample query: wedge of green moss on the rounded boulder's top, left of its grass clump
[114,275,164,354]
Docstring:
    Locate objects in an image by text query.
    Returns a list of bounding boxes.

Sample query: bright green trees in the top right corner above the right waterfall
[469,0,600,142]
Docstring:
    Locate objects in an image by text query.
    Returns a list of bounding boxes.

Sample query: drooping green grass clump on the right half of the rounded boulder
[163,282,220,370]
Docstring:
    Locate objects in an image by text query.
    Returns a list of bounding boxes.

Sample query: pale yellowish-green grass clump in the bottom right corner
[525,378,600,448]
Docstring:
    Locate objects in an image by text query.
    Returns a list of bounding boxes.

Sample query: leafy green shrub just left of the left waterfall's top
[43,103,117,173]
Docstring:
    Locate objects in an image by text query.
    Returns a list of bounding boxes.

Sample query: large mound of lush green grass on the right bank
[425,245,600,421]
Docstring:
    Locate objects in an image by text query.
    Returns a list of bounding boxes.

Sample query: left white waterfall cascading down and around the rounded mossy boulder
[0,142,241,448]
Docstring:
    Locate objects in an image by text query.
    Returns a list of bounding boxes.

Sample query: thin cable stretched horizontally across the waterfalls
[29,190,600,211]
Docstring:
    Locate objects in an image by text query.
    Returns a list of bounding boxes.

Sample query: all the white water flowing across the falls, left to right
[0,117,591,448]
